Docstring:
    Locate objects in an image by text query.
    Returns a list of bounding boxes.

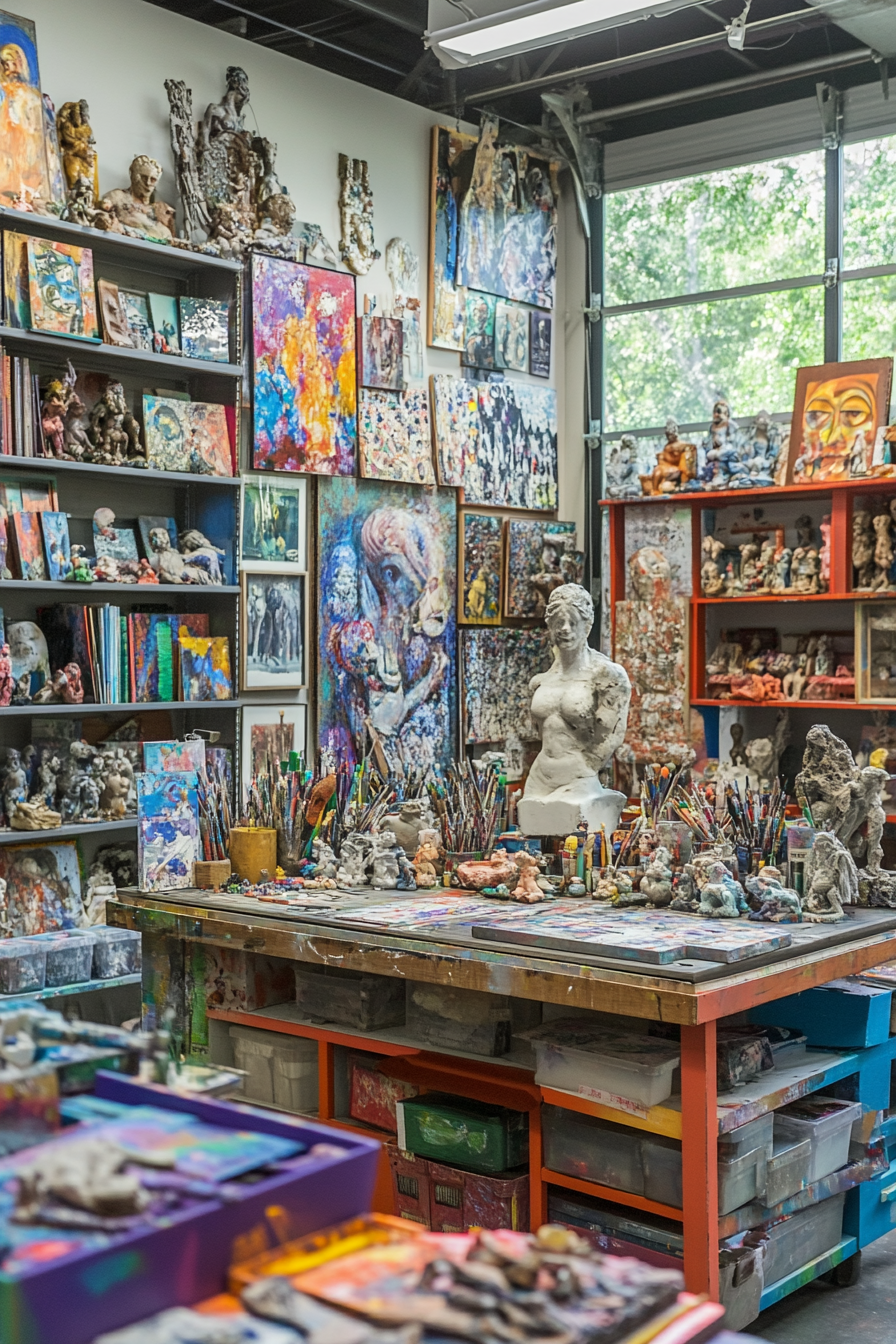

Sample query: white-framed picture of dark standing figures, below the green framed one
[239,569,305,691]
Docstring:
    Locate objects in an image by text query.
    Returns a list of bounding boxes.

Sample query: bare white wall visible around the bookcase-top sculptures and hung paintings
[11,0,584,530]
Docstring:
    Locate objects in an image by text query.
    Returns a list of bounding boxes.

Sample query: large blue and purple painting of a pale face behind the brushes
[317,480,457,773]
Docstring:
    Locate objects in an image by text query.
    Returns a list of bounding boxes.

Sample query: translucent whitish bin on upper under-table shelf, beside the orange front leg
[520,1017,681,1106]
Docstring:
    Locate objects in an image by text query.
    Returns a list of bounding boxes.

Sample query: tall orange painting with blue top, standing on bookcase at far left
[0,11,54,206]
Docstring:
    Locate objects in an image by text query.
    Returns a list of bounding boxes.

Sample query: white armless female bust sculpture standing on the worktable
[519,583,631,836]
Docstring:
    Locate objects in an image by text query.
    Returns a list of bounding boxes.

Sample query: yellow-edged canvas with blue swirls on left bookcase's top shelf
[28,238,99,340]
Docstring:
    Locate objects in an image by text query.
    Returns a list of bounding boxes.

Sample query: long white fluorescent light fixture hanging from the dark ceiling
[424,0,696,70]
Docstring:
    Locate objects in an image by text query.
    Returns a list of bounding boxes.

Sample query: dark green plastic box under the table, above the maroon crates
[395,1093,529,1175]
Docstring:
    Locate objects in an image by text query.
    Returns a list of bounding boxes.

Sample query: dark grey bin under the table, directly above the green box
[404,980,513,1055]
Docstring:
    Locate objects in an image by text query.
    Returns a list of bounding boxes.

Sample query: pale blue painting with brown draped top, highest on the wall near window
[455,117,557,308]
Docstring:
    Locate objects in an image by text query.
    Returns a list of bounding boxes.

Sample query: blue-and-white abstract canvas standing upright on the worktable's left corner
[137,771,201,891]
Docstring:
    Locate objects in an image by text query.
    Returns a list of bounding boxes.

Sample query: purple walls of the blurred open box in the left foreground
[0,1073,380,1344]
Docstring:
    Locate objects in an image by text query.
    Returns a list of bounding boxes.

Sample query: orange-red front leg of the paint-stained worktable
[681,1021,719,1301]
